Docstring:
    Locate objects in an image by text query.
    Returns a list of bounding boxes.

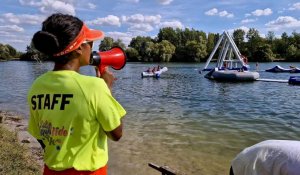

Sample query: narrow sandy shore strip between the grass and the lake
[0,110,43,169]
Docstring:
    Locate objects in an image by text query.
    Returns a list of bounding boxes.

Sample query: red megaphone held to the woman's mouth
[90,47,126,74]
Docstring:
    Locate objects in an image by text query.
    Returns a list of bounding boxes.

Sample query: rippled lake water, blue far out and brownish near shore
[0,61,300,175]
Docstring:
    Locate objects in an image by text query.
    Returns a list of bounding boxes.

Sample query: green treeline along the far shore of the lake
[0,27,300,62]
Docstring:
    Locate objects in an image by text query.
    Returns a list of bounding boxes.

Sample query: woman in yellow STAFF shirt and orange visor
[28,13,126,175]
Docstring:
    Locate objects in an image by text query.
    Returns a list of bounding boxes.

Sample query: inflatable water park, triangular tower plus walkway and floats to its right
[199,31,300,85]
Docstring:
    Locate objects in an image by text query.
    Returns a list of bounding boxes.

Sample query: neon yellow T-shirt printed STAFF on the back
[28,70,126,171]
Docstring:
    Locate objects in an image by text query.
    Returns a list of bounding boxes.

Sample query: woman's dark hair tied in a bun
[32,13,83,62]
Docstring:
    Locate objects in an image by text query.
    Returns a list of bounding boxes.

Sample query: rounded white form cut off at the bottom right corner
[229,140,300,175]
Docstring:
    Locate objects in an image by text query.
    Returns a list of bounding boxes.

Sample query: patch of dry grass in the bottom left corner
[0,125,42,175]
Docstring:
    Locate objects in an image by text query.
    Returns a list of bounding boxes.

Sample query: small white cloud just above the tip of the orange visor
[86,15,121,27]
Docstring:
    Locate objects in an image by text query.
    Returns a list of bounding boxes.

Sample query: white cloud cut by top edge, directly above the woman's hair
[19,0,75,15]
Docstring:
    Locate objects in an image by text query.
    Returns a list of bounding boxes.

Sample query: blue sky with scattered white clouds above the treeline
[0,0,300,52]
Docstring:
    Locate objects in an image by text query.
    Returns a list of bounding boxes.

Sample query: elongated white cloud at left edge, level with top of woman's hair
[2,13,45,25]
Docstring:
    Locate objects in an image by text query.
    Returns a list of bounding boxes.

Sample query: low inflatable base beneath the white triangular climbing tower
[205,68,259,82]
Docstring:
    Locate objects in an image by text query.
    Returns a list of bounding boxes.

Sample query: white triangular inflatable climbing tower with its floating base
[201,31,259,82]
